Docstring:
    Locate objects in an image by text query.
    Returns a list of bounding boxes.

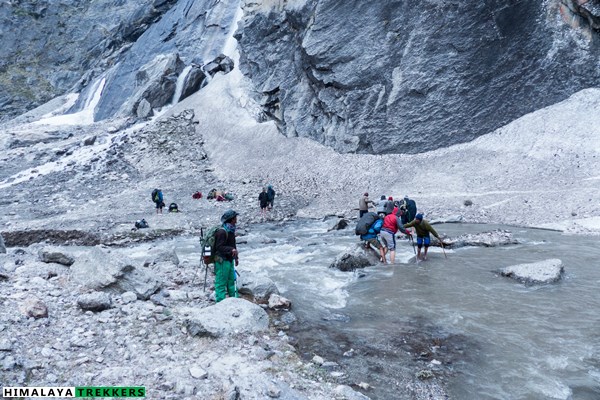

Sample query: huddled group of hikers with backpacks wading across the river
[356,193,444,264]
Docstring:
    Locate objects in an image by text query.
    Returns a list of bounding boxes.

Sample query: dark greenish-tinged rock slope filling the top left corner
[0,0,176,121]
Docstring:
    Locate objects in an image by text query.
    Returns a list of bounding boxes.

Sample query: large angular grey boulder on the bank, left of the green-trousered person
[70,247,161,300]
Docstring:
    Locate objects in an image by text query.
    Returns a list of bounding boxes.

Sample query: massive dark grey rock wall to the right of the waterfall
[237,0,600,153]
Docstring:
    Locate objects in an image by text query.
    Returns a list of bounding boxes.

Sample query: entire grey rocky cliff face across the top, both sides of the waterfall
[0,0,600,154]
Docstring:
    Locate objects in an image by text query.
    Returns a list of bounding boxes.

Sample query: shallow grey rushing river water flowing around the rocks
[178,220,600,400]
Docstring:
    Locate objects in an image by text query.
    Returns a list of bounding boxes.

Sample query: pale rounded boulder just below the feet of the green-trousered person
[183,297,269,337]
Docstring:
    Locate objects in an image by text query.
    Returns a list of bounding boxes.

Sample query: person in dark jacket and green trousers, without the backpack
[215,210,239,303]
